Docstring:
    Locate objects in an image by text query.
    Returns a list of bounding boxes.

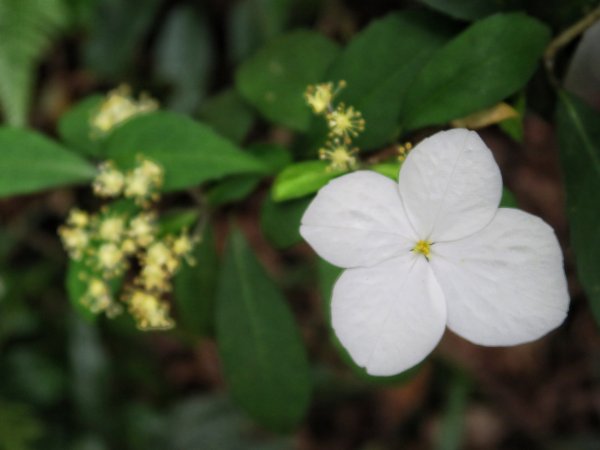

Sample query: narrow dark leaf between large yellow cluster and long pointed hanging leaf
[174,227,219,336]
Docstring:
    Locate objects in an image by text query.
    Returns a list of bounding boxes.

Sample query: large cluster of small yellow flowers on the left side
[58,158,196,330]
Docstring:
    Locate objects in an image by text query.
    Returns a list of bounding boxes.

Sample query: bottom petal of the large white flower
[331,253,446,376]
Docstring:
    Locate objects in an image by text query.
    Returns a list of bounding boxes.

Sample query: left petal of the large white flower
[300,171,415,267]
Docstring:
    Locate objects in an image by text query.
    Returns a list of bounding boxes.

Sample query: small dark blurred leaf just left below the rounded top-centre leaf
[200,89,254,144]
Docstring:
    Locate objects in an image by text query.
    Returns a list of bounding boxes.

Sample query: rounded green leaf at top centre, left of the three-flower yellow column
[236,31,338,131]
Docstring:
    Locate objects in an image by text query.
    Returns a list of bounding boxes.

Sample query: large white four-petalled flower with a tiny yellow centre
[300,129,569,376]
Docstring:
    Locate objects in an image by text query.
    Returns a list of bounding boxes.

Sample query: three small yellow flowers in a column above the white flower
[304,81,365,171]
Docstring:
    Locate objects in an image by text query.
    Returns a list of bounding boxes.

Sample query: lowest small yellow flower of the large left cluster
[126,289,175,330]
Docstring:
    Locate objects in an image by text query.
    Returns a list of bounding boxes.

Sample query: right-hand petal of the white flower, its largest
[431,208,569,346]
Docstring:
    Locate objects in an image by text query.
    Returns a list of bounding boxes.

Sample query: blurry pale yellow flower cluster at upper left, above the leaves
[91,85,158,136]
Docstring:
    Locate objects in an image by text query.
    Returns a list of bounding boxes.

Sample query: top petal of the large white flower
[399,129,502,242]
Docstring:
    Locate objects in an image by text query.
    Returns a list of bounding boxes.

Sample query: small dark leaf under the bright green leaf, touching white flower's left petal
[260,195,312,249]
